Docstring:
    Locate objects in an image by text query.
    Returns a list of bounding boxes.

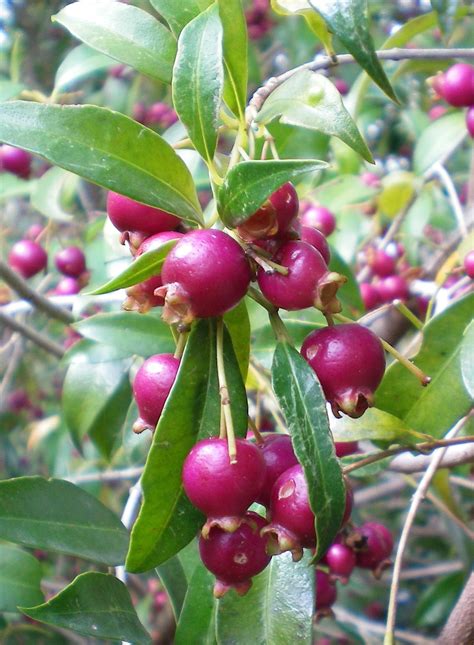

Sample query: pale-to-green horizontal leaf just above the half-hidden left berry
[74,311,174,358]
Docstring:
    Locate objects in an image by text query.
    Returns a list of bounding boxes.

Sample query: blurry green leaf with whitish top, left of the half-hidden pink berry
[62,361,131,459]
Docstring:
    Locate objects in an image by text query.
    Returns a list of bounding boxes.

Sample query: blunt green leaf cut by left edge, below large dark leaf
[0,544,44,612]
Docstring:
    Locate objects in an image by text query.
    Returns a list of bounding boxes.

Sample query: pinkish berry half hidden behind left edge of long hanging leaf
[133,354,179,433]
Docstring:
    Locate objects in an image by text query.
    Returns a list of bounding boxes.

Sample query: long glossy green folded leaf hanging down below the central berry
[127,319,248,572]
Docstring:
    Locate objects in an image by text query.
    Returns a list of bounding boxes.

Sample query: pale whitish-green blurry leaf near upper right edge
[413,110,467,175]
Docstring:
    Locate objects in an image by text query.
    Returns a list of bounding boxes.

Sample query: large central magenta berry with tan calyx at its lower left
[157,229,251,323]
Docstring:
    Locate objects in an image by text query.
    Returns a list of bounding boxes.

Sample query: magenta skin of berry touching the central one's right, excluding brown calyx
[257,241,328,311]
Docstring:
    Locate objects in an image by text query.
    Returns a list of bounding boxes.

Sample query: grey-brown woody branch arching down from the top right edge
[246,48,474,125]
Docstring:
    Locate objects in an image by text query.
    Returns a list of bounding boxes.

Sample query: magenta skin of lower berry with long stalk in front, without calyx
[183,437,265,517]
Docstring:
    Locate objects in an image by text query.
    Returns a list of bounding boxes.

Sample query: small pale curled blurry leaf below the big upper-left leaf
[31,168,77,222]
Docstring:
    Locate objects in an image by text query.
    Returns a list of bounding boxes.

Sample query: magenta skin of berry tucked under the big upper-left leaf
[107,191,180,235]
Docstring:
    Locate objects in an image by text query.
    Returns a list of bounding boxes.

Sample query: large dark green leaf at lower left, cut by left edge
[0,477,128,566]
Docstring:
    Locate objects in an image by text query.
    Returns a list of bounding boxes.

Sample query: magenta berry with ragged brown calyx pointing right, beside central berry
[258,241,345,313]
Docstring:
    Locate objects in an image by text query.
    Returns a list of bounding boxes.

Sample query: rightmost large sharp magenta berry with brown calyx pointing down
[301,323,385,418]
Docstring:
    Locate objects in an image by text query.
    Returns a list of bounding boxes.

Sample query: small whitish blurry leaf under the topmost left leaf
[54,45,117,92]
